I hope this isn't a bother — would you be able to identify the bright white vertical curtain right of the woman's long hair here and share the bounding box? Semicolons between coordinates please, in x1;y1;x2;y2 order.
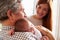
52;0;59;40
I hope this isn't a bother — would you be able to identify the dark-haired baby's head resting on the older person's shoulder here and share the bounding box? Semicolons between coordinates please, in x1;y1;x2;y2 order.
15;19;31;32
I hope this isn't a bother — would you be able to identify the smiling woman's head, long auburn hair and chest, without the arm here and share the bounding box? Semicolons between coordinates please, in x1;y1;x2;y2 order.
28;0;52;31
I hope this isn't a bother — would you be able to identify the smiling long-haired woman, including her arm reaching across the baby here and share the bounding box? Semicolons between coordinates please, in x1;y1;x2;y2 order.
28;0;55;40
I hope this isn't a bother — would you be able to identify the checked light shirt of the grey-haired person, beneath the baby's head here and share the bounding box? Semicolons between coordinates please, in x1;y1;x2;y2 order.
0;31;37;40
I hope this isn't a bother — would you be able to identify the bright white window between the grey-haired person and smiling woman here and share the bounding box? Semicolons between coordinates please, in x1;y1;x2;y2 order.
22;0;35;16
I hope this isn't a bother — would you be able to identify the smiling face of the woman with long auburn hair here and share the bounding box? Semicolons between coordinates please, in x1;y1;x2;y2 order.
36;4;48;19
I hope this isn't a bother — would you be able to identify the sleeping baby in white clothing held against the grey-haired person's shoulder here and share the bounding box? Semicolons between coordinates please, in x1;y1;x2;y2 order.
10;19;42;40
